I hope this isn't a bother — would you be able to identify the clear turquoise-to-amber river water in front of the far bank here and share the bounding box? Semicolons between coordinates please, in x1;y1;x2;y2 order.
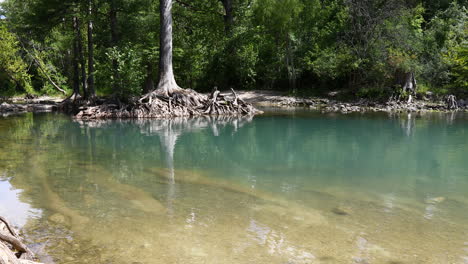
0;111;468;264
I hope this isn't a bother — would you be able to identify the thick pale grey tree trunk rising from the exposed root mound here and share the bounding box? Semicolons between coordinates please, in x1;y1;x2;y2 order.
157;0;180;96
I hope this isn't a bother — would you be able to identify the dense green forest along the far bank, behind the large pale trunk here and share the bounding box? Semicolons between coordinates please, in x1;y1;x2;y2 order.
0;0;468;98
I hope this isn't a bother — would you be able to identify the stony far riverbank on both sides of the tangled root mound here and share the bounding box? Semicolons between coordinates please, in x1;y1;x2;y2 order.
0;90;468;116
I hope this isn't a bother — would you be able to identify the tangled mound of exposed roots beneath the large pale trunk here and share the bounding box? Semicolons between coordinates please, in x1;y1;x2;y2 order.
66;88;261;119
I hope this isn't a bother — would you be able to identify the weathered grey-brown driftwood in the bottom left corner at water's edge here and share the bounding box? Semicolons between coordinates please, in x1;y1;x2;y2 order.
0;216;41;264
